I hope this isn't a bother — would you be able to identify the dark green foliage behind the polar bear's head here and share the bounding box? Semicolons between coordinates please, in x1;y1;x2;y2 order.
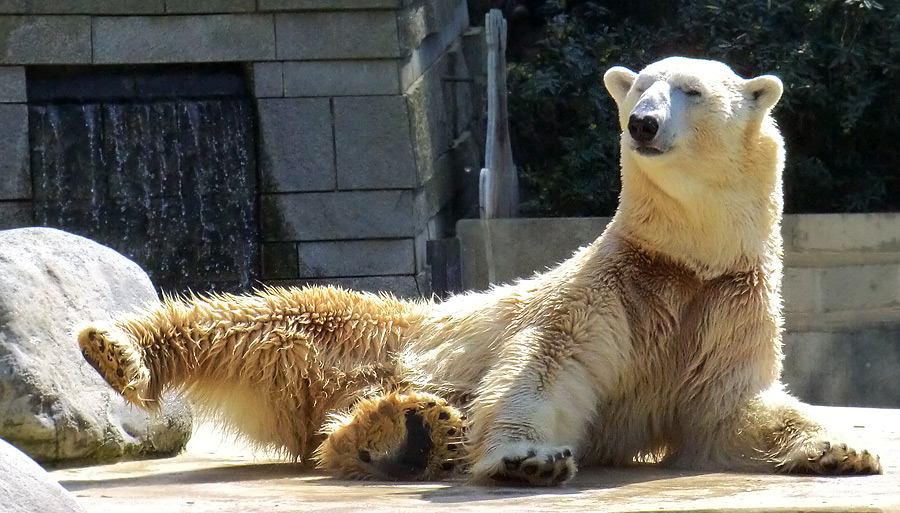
509;0;900;216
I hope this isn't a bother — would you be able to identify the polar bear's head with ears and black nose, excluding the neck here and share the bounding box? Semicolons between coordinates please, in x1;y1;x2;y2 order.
603;57;782;192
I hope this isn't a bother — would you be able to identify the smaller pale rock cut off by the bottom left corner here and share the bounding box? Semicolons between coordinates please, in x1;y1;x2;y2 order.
0;440;84;513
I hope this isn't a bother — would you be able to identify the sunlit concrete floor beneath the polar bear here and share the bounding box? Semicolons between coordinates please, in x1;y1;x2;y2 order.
51;408;900;513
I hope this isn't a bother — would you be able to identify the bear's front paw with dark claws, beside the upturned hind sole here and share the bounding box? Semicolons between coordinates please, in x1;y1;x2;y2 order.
472;443;577;486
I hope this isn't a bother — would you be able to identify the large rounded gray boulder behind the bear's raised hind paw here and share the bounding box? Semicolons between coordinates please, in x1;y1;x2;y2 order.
0;228;191;463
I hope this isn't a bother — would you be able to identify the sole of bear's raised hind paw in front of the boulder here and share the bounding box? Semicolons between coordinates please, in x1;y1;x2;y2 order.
78;327;151;408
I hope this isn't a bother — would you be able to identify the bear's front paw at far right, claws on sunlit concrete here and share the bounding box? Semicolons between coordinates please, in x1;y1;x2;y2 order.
778;438;882;476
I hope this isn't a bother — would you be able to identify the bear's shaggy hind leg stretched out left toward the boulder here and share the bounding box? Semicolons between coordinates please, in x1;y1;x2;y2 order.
78;287;414;462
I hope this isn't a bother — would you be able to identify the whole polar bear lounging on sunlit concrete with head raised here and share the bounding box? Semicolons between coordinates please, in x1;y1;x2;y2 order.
78;57;882;485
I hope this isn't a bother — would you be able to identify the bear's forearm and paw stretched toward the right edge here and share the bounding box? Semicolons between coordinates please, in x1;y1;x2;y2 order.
700;387;882;475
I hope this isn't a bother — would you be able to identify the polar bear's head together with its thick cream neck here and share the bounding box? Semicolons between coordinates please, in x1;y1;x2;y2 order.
604;57;784;276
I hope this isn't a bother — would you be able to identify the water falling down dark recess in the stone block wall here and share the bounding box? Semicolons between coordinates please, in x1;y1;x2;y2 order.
29;67;259;292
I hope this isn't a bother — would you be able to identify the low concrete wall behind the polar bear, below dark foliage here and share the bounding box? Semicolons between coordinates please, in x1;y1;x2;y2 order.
457;214;900;407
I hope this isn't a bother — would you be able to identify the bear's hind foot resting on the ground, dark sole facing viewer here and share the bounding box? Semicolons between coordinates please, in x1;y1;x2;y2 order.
314;392;464;479
